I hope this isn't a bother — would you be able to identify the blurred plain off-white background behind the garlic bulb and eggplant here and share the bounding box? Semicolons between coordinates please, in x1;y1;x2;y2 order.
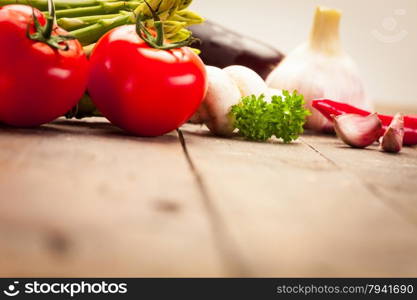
192;0;417;110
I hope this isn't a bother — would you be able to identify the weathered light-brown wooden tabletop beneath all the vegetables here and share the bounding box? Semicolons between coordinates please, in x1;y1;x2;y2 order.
0;119;417;277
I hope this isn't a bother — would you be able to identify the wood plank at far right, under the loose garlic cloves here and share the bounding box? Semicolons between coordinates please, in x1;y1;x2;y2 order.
303;135;417;226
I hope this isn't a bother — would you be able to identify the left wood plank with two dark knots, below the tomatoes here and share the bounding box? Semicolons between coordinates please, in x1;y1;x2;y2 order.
0;120;227;277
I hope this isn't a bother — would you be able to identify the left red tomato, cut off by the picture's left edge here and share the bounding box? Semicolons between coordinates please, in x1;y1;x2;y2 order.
0;5;88;127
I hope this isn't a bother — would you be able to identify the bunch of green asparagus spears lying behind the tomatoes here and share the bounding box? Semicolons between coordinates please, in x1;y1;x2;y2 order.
0;0;203;47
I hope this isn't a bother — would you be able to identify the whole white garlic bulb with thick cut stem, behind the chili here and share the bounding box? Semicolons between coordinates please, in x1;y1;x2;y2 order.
267;7;372;131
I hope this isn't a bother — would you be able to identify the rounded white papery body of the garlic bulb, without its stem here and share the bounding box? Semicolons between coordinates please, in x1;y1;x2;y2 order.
266;44;372;131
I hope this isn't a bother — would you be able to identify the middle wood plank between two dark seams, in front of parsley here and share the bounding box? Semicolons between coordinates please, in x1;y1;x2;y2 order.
183;125;417;276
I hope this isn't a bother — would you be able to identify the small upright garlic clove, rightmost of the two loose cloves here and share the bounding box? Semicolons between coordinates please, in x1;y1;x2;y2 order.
380;114;404;153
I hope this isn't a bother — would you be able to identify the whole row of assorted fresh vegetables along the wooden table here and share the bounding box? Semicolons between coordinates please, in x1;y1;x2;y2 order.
0;0;417;153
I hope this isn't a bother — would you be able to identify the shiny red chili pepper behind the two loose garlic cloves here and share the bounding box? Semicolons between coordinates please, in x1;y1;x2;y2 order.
312;99;417;146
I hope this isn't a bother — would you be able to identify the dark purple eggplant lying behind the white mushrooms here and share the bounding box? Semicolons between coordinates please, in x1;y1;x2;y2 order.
190;21;284;79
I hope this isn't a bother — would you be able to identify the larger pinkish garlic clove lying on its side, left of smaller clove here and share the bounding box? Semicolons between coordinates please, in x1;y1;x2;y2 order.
334;114;382;148
